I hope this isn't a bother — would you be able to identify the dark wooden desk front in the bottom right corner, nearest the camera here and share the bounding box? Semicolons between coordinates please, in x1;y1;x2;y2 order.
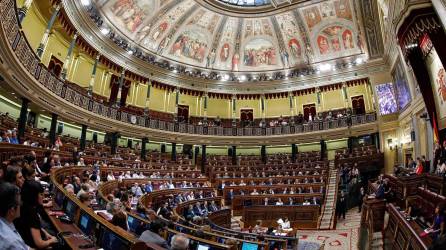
386;204;432;250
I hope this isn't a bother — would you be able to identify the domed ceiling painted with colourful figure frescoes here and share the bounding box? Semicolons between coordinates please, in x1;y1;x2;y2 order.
93;0;364;72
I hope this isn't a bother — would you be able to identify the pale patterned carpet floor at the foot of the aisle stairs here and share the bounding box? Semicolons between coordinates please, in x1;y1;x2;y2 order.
297;208;361;250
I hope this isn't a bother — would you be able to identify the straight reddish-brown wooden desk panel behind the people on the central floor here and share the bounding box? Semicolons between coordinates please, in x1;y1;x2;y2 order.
243;205;320;229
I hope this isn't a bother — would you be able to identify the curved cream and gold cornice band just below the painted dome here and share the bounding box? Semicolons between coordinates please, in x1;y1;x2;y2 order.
58;0;387;94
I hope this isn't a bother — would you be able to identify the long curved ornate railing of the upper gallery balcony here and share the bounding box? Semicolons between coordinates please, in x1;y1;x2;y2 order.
0;0;376;136
